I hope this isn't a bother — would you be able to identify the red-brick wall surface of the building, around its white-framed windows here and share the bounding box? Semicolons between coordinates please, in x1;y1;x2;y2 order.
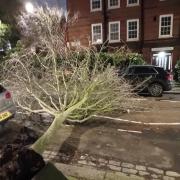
67;0;180;65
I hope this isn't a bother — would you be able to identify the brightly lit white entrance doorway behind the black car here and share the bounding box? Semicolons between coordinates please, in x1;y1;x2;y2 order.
152;52;172;71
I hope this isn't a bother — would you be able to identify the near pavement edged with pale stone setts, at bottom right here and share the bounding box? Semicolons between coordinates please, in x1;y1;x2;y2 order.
44;152;180;180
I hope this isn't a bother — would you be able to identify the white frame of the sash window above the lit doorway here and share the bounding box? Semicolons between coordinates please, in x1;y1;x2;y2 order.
159;14;174;38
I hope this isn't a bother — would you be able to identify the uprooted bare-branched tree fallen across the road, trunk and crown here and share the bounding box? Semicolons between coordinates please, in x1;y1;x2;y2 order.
5;8;139;153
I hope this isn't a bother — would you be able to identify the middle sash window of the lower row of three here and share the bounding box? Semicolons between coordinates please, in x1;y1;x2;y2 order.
109;21;120;42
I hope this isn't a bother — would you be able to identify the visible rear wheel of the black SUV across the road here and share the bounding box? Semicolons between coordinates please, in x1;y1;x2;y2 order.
148;83;163;97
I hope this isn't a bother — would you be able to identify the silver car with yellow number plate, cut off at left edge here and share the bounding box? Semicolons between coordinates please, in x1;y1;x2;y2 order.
0;85;16;126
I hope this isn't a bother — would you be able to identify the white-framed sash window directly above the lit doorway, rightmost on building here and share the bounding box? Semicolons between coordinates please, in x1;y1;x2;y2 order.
159;14;173;38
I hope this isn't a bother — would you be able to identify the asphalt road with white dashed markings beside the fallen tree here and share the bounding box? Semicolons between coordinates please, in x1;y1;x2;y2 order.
0;94;180;179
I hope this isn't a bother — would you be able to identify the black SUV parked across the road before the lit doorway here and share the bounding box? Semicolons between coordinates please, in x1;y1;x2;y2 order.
123;65;173;97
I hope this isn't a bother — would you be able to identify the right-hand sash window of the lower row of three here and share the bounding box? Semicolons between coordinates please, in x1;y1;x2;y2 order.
127;19;139;41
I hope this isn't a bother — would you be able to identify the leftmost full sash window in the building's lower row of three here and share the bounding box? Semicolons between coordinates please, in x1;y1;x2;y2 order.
91;23;103;44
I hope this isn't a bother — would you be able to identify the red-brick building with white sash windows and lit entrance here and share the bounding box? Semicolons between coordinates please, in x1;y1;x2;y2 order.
67;0;180;70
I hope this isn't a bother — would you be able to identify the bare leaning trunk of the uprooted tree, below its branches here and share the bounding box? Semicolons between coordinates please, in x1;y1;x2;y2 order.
31;113;67;154
